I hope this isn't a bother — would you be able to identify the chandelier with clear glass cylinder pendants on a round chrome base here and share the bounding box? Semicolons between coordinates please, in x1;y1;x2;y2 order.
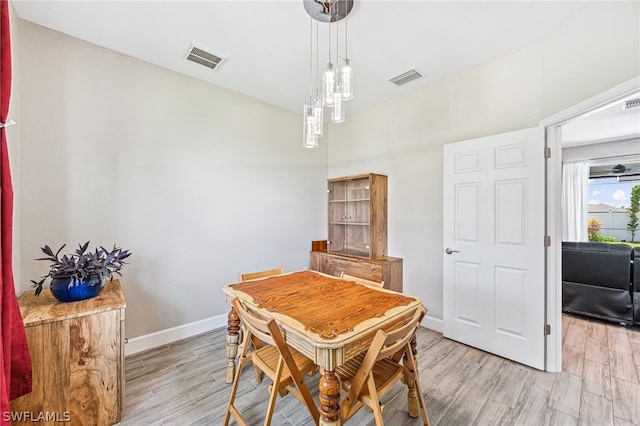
302;0;354;148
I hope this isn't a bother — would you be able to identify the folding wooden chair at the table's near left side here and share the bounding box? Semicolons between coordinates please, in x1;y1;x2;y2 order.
224;298;320;426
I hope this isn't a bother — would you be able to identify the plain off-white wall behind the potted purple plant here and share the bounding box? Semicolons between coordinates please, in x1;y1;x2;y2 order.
19;21;327;337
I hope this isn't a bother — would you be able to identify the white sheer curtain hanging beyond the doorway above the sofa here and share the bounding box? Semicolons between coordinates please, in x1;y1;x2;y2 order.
562;160;589;241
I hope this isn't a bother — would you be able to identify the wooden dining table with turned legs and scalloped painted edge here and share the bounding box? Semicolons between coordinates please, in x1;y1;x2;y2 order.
223;270;422;426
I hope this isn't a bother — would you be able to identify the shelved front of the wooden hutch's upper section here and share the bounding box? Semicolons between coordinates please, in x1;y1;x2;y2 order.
328;177;371;257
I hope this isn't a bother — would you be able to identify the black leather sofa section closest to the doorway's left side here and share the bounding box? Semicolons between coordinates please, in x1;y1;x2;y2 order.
562;242;640;324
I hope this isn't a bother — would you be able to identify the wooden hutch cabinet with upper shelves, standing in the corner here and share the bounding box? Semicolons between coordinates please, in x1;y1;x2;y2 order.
310;173;402;292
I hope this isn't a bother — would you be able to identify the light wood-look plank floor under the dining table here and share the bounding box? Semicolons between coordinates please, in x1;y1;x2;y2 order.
120;315;640;426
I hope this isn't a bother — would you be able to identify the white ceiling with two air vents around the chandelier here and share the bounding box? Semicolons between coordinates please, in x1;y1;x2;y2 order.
13;0;640;142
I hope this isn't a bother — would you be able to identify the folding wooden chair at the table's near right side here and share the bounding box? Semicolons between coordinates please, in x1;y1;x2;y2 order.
335;306;429;426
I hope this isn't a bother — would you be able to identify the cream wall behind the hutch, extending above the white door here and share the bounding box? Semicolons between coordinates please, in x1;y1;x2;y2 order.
329;2;640;325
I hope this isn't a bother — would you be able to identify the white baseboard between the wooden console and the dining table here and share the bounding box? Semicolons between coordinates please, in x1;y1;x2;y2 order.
124;314;227;356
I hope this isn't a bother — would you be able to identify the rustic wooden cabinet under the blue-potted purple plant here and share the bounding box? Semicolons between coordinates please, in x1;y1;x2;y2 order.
11;280;126;425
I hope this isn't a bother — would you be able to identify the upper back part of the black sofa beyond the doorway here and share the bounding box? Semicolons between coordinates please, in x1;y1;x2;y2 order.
562;242;632;291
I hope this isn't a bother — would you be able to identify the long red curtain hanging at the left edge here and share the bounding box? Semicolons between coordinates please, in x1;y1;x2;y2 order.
0;0;31;425
